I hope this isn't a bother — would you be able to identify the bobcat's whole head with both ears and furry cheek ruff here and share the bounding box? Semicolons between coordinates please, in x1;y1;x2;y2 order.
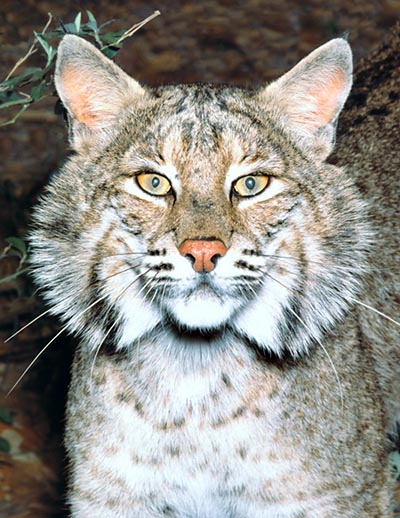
32;36;366;355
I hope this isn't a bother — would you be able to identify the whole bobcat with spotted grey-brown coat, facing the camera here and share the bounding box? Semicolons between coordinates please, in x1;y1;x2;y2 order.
31;35;399;518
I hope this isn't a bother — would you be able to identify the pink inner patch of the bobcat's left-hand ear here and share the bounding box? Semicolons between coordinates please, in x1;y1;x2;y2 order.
61;67;100;126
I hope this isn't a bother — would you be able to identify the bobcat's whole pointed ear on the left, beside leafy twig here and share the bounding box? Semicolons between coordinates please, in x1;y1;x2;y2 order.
55;35;146;147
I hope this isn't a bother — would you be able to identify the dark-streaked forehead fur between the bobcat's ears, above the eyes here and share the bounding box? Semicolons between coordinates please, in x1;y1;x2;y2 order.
134;85;272;173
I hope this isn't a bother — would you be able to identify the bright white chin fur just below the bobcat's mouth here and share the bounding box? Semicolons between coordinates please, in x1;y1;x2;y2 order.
167;294;237;329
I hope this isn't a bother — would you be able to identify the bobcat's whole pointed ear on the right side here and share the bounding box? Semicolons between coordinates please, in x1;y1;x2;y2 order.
260;38;352;159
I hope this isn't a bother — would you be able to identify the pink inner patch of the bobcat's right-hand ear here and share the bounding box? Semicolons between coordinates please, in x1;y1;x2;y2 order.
304;71;346;129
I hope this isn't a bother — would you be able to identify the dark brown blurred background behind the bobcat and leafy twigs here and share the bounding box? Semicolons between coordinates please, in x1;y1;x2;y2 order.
0;0;400;518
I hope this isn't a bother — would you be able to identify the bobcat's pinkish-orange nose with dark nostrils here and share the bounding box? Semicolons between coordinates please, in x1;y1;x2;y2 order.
179;239;227;273
